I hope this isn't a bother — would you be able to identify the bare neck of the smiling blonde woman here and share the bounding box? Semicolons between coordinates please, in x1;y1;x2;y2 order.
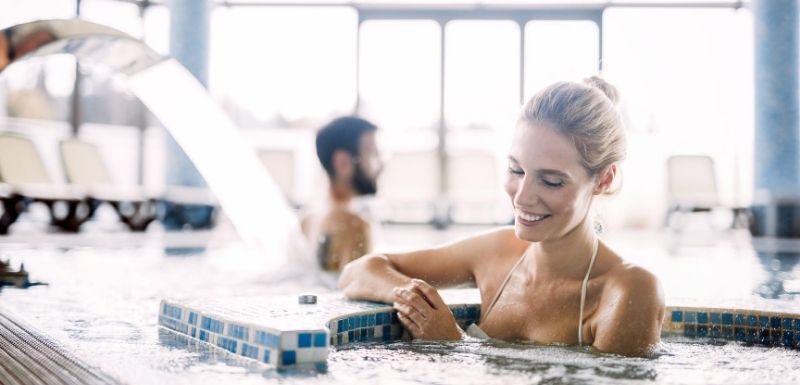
529;216;597;279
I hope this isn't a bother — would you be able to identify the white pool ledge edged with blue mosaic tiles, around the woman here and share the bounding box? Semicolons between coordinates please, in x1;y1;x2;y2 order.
159;289;800;367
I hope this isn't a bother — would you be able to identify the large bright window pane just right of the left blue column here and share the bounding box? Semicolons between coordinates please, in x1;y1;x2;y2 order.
209;6;357;128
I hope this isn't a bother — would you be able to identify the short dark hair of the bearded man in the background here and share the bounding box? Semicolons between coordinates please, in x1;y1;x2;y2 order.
317;116;378;178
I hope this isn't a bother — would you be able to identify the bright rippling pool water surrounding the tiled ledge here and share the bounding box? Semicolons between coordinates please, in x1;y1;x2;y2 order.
0;229;800;384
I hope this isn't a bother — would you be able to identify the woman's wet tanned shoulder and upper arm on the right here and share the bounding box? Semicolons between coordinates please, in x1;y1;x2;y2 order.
593;266;664;356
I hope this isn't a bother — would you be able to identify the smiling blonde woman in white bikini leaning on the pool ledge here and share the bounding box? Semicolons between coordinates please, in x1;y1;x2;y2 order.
339;77;664;355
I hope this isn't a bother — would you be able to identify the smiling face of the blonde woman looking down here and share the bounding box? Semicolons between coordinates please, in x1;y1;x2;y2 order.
506;122;595;242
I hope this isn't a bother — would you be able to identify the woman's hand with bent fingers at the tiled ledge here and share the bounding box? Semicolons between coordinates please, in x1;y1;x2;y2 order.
393;279;462;340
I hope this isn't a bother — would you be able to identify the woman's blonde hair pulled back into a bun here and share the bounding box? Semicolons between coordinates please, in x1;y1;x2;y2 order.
520;76;626;182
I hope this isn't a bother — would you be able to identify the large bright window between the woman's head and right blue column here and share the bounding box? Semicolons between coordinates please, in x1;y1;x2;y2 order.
603;8;754;223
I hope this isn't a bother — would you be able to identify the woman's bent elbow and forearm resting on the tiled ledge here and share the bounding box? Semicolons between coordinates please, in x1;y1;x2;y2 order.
339;255;411;303
